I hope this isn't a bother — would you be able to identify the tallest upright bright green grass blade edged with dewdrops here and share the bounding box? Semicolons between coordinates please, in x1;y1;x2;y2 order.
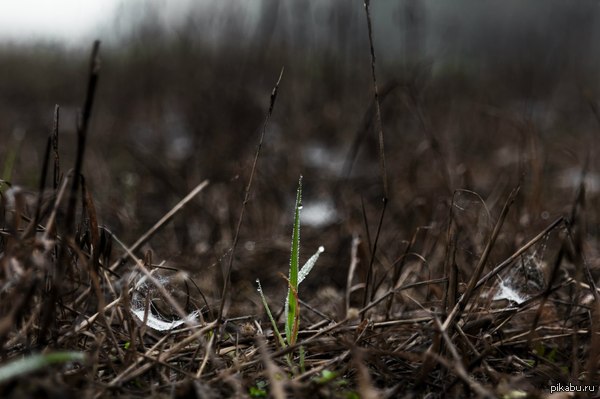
285;176;302;343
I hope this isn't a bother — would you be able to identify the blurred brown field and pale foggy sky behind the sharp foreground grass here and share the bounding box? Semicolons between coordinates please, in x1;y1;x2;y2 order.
0;0;600;312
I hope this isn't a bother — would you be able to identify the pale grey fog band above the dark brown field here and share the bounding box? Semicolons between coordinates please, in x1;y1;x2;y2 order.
0;0;600;66
